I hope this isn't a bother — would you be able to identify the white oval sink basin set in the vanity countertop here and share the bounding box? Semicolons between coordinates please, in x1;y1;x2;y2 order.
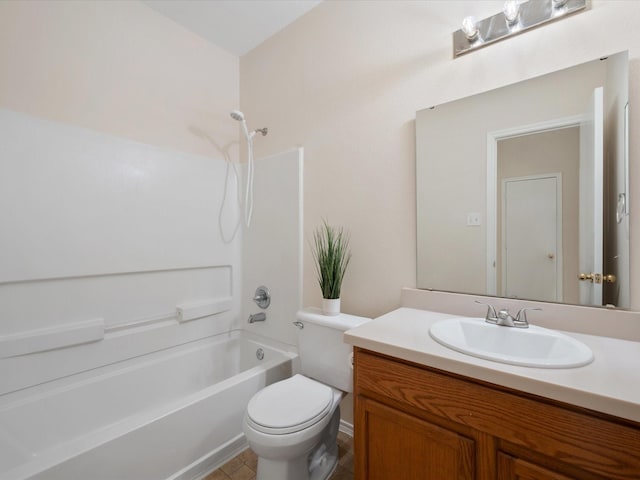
429;317;593;368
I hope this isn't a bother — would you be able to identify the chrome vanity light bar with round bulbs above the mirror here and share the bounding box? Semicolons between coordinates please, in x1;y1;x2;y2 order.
453;0;587;58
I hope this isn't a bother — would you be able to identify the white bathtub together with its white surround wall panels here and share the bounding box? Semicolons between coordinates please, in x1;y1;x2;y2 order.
0;109;302;480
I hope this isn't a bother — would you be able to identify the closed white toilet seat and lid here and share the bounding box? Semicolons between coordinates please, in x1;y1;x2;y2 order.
246;375;333;435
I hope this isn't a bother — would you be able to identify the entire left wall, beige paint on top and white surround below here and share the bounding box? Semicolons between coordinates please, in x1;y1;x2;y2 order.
0;1;242;396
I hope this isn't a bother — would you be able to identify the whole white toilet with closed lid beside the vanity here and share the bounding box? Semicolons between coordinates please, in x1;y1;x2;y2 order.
242;308;369;480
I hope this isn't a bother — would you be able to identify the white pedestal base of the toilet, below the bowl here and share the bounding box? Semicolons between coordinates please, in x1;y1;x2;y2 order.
256;407;340;480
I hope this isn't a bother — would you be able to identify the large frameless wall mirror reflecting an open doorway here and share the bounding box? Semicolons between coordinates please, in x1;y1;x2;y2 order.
416;52;629;308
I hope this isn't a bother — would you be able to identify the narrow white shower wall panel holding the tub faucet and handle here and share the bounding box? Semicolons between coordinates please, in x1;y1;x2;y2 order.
242;148;307;345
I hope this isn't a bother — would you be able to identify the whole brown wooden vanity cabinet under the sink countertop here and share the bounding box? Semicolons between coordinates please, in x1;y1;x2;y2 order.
354;347;640;480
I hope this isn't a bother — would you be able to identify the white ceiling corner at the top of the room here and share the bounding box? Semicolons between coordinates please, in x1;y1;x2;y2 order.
144;0;321;56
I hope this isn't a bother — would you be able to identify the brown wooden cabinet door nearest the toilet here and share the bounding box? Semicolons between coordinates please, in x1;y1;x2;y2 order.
355;396;475;480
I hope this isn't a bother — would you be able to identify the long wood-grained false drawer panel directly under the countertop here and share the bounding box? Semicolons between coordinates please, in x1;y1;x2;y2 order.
355;349;640;480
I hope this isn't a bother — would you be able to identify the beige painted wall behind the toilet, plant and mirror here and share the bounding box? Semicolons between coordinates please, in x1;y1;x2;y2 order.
240;0;640;316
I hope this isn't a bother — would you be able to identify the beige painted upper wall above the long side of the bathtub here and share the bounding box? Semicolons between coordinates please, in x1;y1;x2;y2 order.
0;0;239;158
